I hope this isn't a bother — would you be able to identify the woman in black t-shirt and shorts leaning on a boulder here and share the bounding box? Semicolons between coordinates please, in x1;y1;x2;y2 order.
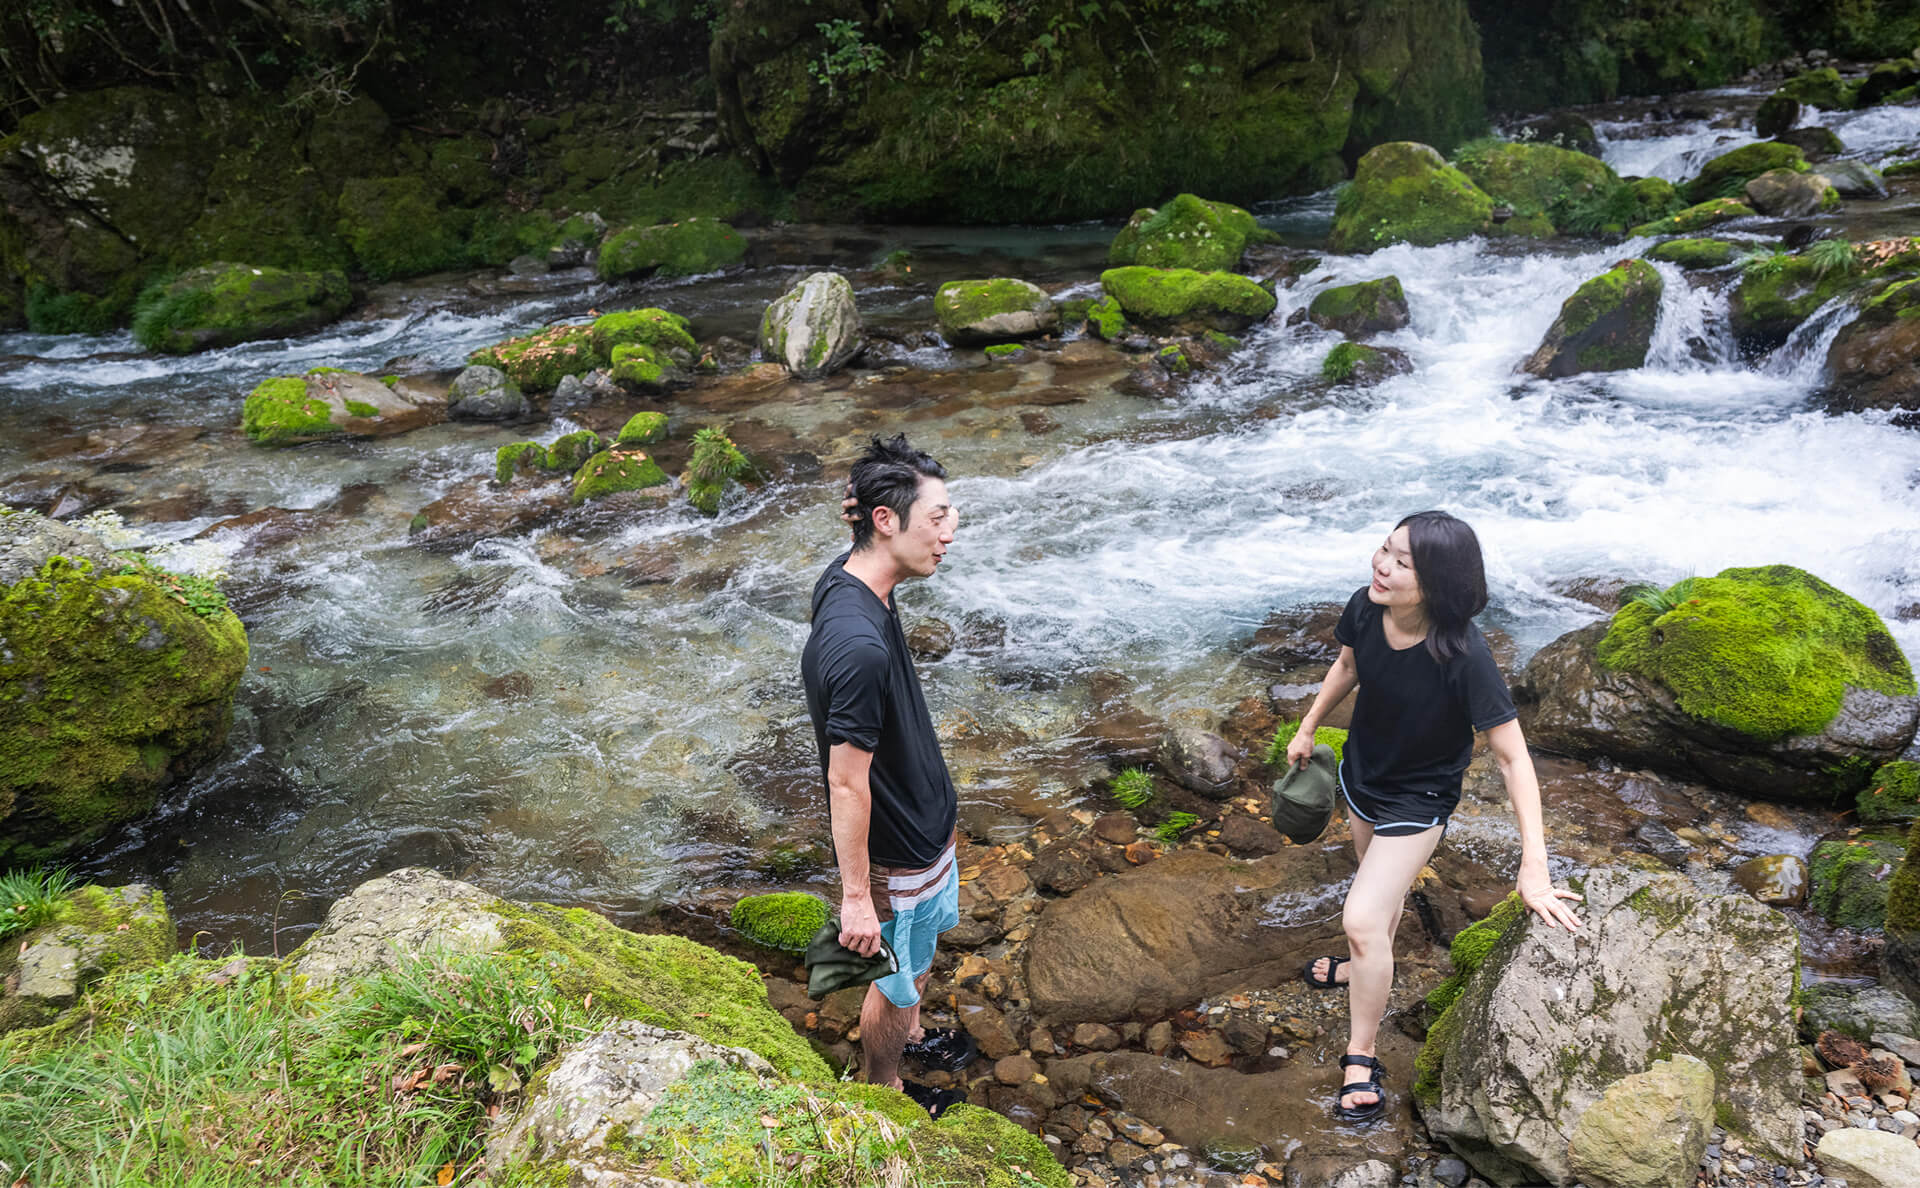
1286;511;1580;1123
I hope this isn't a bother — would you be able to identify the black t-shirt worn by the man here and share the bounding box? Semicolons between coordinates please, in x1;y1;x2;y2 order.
801;553;958;867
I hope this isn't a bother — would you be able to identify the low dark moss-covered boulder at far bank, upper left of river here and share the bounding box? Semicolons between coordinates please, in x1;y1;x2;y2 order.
132;263;353;355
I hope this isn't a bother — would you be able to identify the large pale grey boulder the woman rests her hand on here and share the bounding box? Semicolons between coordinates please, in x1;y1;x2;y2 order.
1423;869;1801;1186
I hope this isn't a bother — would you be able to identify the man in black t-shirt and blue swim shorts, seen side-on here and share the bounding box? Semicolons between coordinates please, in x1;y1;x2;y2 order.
801;436;973;1117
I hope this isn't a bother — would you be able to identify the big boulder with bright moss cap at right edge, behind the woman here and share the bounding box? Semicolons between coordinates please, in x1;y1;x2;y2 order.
1515;566;1920;802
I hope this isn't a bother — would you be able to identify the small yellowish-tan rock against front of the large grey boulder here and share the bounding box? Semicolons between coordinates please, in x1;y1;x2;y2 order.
1567;1054;1713;1188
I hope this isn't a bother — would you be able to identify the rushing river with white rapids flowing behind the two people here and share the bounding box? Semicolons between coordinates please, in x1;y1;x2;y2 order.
0;94;1920;952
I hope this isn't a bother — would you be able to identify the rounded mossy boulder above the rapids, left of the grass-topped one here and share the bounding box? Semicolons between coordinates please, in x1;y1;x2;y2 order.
1329;140;1494;251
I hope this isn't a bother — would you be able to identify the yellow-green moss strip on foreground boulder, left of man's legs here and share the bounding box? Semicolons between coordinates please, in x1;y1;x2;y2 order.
495;902;829;1081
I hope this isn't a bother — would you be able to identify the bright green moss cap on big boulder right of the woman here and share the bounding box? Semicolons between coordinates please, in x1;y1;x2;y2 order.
1596;564;1914;741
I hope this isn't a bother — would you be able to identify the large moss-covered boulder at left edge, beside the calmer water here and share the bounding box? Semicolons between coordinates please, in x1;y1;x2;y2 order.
0;512;248;862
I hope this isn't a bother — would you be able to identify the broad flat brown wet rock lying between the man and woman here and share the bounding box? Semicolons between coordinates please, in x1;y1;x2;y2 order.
1027;850;1348;1021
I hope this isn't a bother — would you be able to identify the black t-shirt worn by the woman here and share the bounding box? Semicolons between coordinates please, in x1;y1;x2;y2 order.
1332;587;1519;796
